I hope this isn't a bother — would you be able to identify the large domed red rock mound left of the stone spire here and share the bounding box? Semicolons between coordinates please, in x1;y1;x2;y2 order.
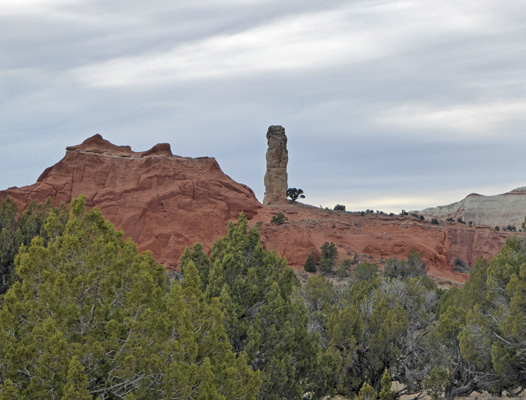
0;135;261;267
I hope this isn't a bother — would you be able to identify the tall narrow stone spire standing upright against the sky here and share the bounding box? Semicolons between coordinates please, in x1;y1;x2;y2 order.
263;125;289;205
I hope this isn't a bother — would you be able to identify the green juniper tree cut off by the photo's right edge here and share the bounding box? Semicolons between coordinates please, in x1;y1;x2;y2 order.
455;238;526;394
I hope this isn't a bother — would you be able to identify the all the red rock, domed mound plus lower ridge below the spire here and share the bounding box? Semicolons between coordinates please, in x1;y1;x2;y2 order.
0;135;520;283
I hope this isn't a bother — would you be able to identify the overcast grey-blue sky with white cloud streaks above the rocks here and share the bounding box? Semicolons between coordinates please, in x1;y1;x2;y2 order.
0;0;526;212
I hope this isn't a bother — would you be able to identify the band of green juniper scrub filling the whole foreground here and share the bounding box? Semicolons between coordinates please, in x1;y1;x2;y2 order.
0;199;526;400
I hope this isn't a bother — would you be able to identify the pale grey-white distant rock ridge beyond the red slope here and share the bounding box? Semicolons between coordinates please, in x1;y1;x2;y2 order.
418;187;526;230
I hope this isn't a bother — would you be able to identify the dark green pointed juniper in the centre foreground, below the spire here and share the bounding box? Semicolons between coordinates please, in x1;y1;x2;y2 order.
181;214;325;399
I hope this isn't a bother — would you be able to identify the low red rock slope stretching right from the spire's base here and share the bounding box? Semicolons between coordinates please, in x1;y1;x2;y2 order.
251;204;524;284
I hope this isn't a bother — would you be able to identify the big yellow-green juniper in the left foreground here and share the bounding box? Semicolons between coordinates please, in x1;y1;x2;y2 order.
0;198;259;399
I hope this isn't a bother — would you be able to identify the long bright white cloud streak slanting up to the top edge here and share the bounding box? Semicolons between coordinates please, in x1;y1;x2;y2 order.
69;1;520;87
